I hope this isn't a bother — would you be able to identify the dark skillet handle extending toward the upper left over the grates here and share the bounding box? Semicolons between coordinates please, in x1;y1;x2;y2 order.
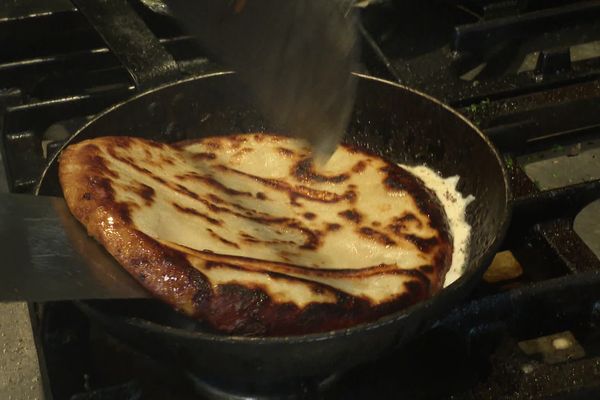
71;0;183;90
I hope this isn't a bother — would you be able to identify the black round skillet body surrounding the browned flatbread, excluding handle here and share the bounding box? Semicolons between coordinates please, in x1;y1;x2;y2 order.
36;73;510;387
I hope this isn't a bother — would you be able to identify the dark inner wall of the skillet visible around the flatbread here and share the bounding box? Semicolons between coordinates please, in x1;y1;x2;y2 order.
38;73;508;338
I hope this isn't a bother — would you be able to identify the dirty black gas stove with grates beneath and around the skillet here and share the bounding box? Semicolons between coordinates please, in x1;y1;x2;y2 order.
0;0;600;400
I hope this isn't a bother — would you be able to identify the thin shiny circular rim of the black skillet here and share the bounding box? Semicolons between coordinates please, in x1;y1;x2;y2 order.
34;71;513;345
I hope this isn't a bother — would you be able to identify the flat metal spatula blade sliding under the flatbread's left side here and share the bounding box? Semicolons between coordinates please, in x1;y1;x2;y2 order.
0;193;149;302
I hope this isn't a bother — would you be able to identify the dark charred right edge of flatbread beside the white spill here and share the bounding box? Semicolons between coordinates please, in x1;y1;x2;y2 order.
380;164;450;242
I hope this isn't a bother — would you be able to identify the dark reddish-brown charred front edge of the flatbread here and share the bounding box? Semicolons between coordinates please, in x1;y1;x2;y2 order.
186;256;429;336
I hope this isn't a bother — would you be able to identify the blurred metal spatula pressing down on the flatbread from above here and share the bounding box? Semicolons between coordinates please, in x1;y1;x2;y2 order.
165;0;358;161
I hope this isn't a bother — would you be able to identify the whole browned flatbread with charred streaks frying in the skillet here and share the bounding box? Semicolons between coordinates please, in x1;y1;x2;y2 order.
59;134;452;335
